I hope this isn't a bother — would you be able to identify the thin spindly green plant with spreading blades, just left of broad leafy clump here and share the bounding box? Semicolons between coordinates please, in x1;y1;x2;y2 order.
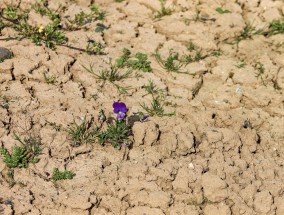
83;62;133;93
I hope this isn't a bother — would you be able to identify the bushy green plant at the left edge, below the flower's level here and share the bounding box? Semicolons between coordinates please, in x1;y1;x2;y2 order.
0;134;42;168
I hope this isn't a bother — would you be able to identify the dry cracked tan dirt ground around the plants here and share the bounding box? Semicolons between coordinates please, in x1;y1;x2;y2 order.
0;0;284;215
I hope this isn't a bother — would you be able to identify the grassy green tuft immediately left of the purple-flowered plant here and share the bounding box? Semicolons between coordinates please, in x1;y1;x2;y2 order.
67;116;97;146
